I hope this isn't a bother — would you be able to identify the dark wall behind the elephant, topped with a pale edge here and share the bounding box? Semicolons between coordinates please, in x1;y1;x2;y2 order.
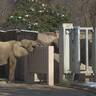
0;29;38;79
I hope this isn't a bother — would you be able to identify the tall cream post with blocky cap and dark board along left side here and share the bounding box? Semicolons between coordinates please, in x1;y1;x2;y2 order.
59;23;73;82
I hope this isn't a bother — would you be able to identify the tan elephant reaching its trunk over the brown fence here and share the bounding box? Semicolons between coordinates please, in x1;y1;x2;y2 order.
0;39;39;82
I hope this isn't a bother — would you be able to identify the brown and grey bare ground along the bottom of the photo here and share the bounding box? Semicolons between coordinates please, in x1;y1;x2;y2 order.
0;84;96;96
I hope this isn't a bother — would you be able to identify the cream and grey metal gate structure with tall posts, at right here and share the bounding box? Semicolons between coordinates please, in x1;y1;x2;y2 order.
59;23;95;82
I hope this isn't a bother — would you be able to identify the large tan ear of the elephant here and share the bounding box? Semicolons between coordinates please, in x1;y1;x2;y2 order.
13;42;28;57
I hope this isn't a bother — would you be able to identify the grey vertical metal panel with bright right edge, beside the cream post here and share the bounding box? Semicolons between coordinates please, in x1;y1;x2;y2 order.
71;27;80;73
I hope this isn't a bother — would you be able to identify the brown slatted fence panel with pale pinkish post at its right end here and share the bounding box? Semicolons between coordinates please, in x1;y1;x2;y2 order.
18;46;54;86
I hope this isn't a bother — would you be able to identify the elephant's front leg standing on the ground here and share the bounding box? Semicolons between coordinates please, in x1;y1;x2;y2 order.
9;57;16;82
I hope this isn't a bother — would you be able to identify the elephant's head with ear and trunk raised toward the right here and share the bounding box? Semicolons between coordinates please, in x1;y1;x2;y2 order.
13;39;38;57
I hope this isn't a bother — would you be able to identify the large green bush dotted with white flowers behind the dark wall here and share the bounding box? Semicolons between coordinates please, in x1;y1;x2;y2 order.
6;0;71;32
